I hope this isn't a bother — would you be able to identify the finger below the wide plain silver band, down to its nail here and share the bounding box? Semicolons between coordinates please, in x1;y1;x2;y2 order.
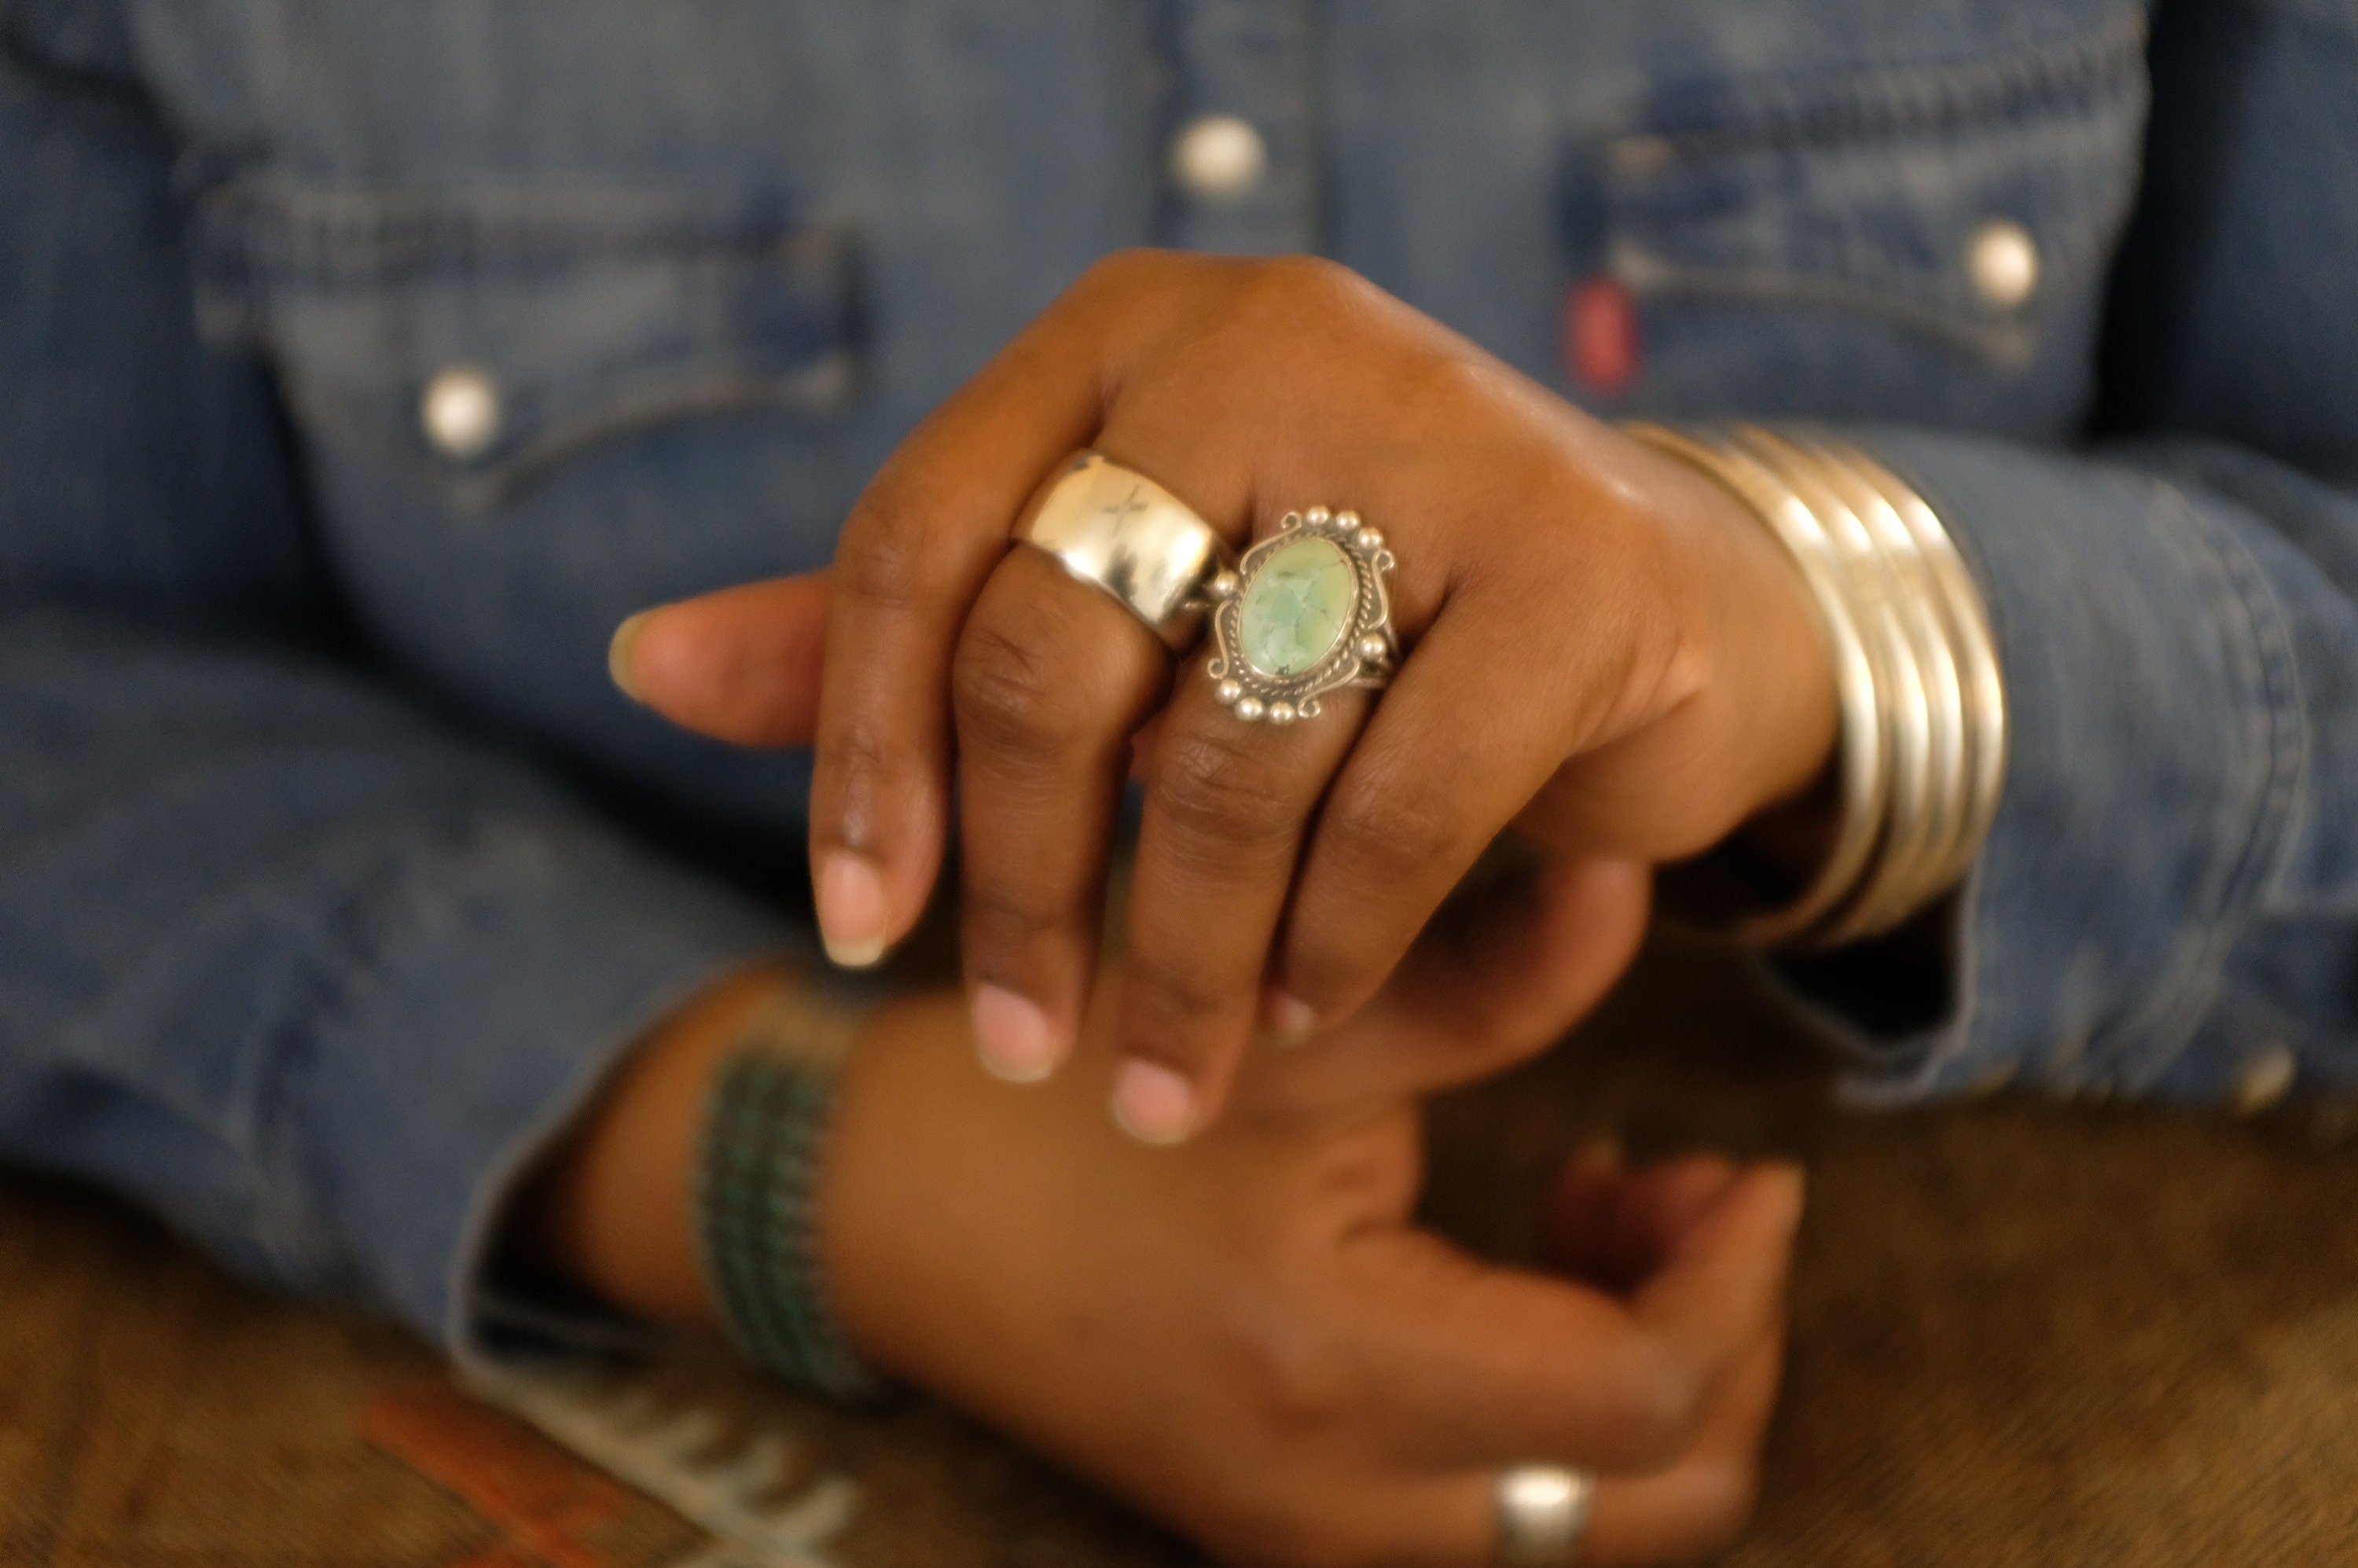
953;549;1170;1082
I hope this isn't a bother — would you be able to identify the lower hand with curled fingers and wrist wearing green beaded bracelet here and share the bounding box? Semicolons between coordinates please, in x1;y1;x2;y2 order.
526;967;1802;1566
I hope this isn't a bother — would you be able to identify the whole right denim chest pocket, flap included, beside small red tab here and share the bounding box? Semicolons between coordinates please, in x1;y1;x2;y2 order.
1575;14;2146;427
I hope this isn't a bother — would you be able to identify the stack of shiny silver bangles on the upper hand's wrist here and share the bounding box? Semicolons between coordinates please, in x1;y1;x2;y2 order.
1625;424;2007;948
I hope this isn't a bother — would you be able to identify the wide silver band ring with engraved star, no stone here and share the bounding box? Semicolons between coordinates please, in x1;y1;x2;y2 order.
1014;453;1229;653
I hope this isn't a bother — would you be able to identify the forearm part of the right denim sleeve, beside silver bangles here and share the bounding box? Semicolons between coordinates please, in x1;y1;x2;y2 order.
1783;431;2358;1101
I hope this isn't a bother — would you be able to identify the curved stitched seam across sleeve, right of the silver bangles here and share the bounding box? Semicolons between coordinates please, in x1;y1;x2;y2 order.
2101;481;2308;1087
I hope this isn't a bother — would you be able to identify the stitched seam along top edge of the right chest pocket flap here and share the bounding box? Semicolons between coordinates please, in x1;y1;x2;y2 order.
1651;12;2146;158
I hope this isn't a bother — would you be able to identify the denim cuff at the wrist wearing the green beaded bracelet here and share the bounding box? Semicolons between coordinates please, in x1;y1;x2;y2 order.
281;821;809;1363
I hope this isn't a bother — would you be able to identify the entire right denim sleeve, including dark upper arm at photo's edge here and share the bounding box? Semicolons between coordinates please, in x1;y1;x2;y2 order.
1787;0;2358;1103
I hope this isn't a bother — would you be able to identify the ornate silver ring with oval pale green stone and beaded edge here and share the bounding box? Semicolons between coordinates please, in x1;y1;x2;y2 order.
1205;507;1401;724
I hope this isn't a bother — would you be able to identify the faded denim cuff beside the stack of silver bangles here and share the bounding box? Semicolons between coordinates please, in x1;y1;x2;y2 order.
1771;431;2306;1103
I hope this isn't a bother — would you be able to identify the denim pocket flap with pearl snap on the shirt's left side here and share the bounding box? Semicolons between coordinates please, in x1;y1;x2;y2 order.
193;177;858;512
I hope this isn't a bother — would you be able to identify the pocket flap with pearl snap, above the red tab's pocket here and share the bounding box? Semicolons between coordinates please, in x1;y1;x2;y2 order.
1596;14;2143;363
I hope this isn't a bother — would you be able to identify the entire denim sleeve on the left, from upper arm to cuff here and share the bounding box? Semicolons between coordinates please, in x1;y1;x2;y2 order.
0;18;797;1351
